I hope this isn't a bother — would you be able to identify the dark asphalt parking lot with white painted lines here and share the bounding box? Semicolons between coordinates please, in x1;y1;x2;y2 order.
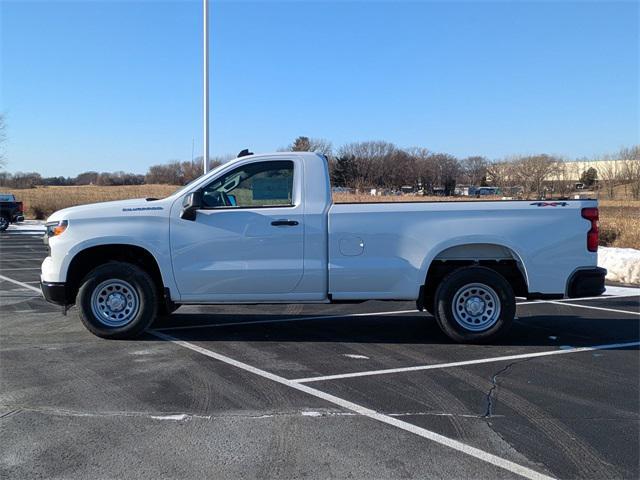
0;231;640;479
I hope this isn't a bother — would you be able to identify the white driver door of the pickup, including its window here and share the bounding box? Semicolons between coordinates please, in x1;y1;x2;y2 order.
170;159;304;302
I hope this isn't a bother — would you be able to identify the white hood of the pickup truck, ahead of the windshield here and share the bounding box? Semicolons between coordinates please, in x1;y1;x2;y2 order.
47;198;171;222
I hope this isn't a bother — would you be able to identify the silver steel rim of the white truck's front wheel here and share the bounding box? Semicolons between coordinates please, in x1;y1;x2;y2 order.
91;279;140;328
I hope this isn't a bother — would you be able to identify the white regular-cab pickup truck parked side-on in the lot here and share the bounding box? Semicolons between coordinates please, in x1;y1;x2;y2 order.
41;152;606;342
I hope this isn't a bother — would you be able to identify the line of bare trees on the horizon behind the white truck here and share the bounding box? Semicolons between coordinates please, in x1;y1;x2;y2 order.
0;136;640;199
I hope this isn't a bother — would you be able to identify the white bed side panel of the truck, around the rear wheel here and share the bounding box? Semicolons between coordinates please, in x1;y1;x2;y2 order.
329;200;597;299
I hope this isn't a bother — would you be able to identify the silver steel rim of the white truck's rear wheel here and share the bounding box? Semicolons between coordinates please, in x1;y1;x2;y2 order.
451;283;500;332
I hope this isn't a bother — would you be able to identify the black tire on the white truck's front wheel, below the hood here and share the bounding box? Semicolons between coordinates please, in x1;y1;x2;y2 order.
76;262;158;339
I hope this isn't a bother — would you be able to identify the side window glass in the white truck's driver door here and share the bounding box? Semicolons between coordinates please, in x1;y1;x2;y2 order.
202;160;293;208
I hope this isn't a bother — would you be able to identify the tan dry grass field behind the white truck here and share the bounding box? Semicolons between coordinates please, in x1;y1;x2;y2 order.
0;185;640;249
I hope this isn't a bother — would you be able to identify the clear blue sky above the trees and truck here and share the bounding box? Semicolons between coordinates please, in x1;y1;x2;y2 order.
0;0;640;175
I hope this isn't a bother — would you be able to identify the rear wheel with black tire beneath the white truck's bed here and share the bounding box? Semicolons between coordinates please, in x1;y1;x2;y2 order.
434;267;516;343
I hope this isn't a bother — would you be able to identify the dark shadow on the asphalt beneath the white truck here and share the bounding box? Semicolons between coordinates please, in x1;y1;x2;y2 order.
145;311;640;349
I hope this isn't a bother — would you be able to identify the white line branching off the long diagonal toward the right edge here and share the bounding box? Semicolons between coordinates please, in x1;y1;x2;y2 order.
291;342;640;383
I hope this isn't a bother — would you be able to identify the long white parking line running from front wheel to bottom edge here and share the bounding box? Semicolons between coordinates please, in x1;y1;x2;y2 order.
150;331;552;480
